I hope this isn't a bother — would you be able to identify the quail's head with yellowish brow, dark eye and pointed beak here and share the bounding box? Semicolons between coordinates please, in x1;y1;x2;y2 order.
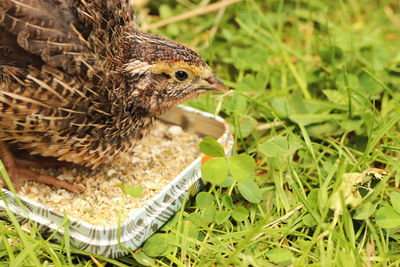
123;30;226;116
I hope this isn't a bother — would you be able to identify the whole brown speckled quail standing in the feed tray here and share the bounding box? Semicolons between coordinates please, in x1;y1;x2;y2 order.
0;0;227;192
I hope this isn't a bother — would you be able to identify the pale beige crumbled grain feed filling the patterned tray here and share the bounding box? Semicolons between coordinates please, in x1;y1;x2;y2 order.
19;121;200;226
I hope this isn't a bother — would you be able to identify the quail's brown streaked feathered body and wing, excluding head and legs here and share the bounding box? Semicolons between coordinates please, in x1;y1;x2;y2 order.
0;0;139;166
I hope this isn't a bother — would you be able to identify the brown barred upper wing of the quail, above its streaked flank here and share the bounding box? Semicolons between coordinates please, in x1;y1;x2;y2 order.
0;0;136;80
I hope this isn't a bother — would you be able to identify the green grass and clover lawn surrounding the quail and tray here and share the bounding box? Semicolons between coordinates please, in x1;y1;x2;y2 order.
0;0;400;266
